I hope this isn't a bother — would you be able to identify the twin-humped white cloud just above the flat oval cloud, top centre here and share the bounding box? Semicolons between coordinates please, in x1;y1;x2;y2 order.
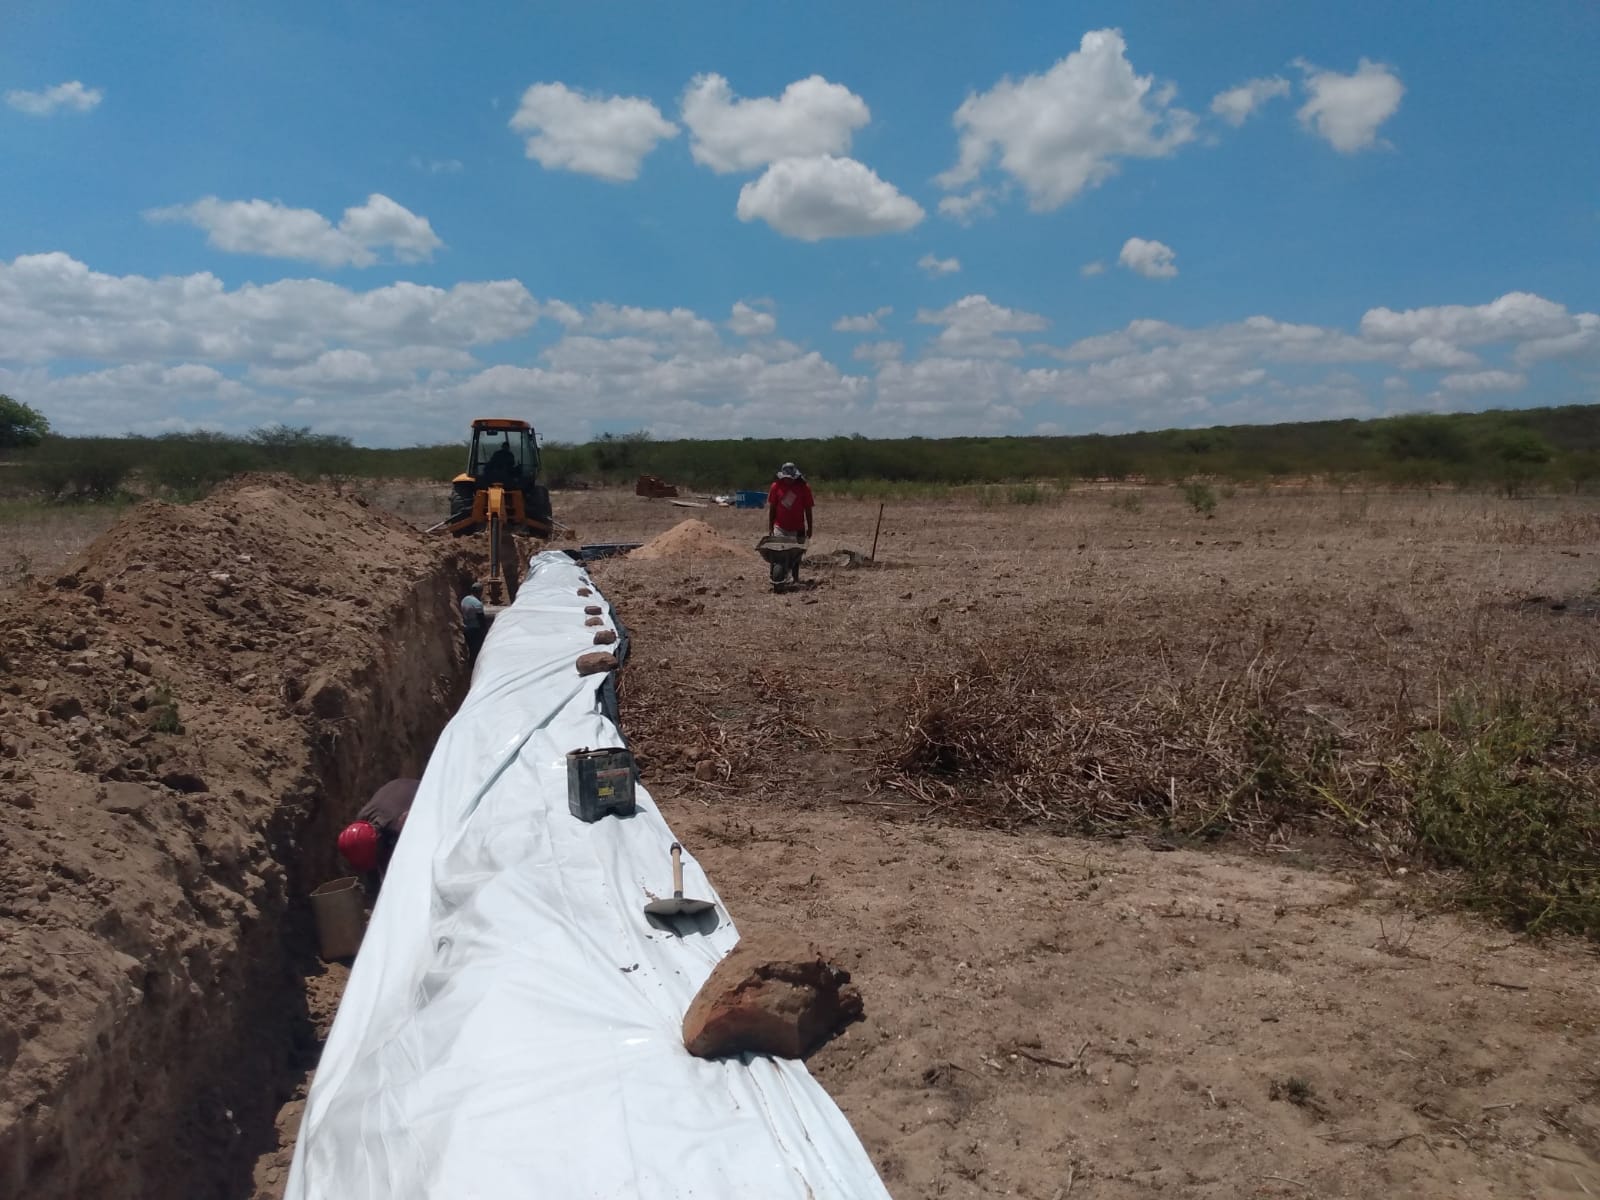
680;75;872;174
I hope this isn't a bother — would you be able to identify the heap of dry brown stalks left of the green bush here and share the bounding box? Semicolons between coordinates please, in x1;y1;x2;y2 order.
880;643;1336;838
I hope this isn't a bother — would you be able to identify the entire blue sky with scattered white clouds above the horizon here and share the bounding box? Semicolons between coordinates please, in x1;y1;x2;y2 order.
0;0;1600;445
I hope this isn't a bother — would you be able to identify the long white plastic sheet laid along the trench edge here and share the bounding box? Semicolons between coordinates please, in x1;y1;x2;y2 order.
286;552;888;1200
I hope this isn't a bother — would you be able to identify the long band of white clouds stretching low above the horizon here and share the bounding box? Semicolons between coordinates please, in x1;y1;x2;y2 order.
0;253;1600;445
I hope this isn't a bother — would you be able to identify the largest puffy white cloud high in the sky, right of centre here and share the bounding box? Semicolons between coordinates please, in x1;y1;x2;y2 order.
939;29;1195;211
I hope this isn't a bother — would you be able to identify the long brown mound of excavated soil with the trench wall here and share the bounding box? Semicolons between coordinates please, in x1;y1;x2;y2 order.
0;477;461;1200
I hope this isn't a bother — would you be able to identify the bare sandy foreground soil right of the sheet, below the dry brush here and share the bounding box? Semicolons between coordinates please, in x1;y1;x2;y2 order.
667;800;1600;1200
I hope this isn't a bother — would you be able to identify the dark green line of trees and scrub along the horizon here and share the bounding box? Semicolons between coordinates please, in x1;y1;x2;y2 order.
0;397;1600;501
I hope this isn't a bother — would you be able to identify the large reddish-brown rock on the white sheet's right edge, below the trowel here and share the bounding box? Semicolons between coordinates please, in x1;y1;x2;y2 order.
683;933;862;1058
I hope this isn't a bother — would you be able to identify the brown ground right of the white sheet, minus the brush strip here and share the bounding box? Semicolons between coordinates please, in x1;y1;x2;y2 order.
562;490;1600;1200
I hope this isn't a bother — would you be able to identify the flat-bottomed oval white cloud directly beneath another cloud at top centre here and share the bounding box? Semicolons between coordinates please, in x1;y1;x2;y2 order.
738;155;923;242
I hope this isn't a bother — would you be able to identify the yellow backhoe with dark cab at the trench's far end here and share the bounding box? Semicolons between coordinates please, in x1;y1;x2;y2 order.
445;418;555;603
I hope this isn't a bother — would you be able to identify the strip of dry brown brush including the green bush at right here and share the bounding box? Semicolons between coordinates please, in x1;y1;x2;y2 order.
875;635;1600;934
